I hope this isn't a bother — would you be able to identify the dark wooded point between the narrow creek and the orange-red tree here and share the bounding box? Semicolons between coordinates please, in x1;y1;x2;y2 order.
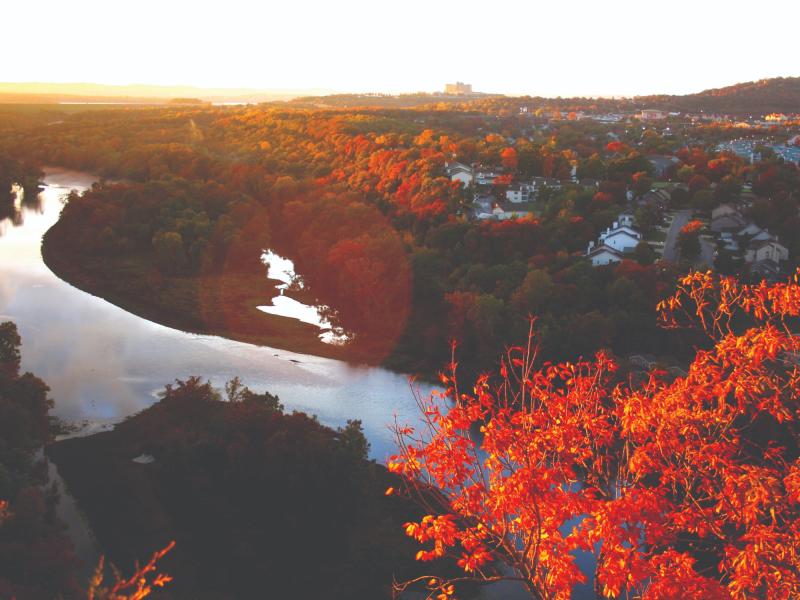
48;378;454;599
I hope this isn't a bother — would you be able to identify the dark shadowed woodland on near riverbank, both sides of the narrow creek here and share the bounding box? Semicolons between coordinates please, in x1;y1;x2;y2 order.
0;322;454;600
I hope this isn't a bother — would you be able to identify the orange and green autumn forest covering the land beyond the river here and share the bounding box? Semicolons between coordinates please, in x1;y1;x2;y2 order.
4;87;800;380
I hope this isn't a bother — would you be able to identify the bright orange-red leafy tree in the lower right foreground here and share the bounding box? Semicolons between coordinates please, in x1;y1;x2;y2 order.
389;273;800;599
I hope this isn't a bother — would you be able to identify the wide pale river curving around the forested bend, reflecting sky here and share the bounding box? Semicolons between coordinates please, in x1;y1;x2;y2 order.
0;169;432;460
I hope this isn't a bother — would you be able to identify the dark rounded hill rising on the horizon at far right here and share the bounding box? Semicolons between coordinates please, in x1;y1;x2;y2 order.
635;77;800;115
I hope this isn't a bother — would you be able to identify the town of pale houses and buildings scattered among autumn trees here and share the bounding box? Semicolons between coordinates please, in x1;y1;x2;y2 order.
444;82;800;280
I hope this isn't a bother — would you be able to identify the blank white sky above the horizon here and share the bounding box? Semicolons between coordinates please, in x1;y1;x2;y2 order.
0;0;800;96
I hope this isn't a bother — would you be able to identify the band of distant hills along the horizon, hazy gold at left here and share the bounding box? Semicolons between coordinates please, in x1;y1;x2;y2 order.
0;77;800;115
